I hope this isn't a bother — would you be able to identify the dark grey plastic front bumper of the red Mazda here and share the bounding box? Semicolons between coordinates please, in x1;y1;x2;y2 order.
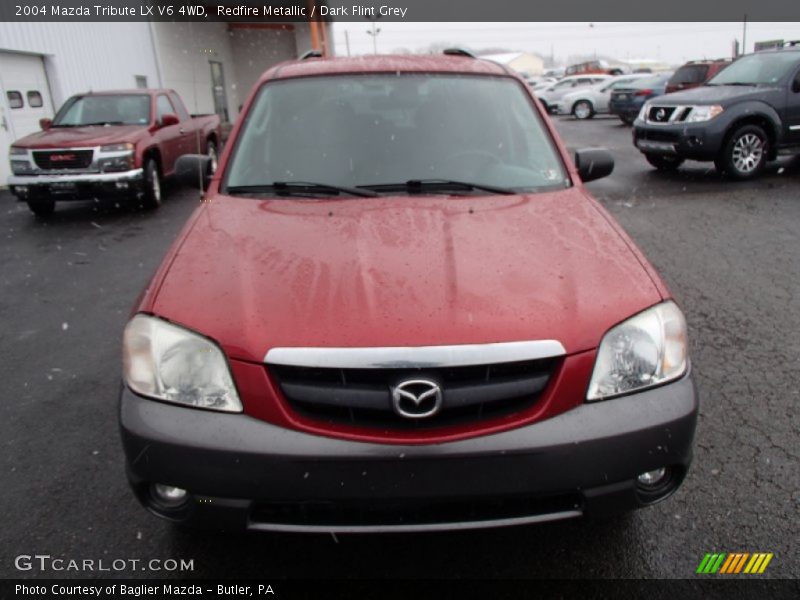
115;375;698;532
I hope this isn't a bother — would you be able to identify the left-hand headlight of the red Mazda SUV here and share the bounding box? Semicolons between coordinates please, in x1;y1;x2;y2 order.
122;314;242;412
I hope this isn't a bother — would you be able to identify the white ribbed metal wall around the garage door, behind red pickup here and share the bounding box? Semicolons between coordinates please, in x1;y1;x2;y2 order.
0;22;159;109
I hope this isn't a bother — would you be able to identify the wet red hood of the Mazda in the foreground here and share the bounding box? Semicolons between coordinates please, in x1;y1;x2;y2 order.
150;188;661;362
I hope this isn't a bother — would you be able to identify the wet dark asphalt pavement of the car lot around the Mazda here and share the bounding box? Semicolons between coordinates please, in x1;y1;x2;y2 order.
0;118;800;578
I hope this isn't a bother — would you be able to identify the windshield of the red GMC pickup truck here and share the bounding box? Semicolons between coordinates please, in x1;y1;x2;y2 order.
53;94;150;127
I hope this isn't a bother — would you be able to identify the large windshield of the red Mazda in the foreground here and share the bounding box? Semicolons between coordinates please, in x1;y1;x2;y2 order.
225;74;569;190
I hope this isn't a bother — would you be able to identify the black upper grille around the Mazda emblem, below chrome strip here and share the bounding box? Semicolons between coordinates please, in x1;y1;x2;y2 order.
268;358;558;430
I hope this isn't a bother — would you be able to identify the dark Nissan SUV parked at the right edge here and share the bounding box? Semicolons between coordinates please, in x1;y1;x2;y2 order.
633;44;800;179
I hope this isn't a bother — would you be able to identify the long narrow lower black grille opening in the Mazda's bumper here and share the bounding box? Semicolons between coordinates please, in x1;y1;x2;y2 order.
250;493;583;527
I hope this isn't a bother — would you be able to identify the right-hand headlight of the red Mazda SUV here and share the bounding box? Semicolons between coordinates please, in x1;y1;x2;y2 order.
586;302;688;400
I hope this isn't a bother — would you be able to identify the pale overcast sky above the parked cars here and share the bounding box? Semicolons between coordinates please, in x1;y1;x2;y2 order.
333;20;800;64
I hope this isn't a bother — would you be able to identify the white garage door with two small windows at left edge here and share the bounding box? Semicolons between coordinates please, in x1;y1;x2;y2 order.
0;52;53;185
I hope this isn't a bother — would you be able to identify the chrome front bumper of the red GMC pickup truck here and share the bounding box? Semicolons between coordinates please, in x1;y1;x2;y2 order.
8;169;144;200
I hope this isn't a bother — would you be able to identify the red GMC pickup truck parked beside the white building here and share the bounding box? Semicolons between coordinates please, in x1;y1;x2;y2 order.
8;89;220;216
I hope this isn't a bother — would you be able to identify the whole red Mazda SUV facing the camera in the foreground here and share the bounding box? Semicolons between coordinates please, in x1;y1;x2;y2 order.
120;53;698;532
